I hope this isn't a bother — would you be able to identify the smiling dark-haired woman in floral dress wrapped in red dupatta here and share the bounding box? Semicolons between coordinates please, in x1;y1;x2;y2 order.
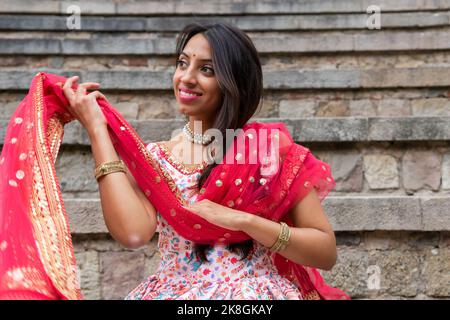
0;23;348;299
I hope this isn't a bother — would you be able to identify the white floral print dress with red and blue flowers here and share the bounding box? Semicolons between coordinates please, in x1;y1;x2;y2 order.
125;143;302;300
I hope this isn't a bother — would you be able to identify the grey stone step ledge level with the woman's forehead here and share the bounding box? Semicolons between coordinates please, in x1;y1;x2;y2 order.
0;29;450;56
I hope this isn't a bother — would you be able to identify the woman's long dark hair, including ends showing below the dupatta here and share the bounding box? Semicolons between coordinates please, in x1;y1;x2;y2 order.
176;23;263;261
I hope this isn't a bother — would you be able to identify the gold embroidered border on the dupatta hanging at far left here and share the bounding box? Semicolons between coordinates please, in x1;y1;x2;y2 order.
30;74;82;299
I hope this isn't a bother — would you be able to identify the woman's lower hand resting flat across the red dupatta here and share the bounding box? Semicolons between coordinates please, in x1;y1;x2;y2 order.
185;199;249;231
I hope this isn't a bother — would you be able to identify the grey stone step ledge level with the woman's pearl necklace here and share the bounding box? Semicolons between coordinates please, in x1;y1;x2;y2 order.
0;117;450;146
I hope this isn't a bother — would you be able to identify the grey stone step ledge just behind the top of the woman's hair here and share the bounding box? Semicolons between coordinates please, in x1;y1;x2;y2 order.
0;11;450;33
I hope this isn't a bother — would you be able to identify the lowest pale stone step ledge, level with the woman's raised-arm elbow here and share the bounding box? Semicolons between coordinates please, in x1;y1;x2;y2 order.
63;194;450;234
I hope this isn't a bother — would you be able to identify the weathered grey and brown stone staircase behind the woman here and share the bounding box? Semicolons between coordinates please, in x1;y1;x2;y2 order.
0;0;450;299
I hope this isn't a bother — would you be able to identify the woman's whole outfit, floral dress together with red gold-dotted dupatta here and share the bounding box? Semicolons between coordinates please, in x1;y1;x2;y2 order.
0;73;349;299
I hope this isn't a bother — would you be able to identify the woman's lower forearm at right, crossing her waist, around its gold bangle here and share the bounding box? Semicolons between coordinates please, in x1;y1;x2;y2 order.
241;212;336;270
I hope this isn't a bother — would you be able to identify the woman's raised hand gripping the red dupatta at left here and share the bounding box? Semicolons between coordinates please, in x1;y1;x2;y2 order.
63;76;107;134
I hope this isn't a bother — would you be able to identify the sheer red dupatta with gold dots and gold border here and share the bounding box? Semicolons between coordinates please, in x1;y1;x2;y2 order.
0;73;349;299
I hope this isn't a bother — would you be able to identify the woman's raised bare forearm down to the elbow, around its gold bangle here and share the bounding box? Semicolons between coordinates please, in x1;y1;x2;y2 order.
88;126;156;247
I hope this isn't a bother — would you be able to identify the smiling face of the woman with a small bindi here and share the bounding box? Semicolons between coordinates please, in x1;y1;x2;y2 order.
173;33;222;122
